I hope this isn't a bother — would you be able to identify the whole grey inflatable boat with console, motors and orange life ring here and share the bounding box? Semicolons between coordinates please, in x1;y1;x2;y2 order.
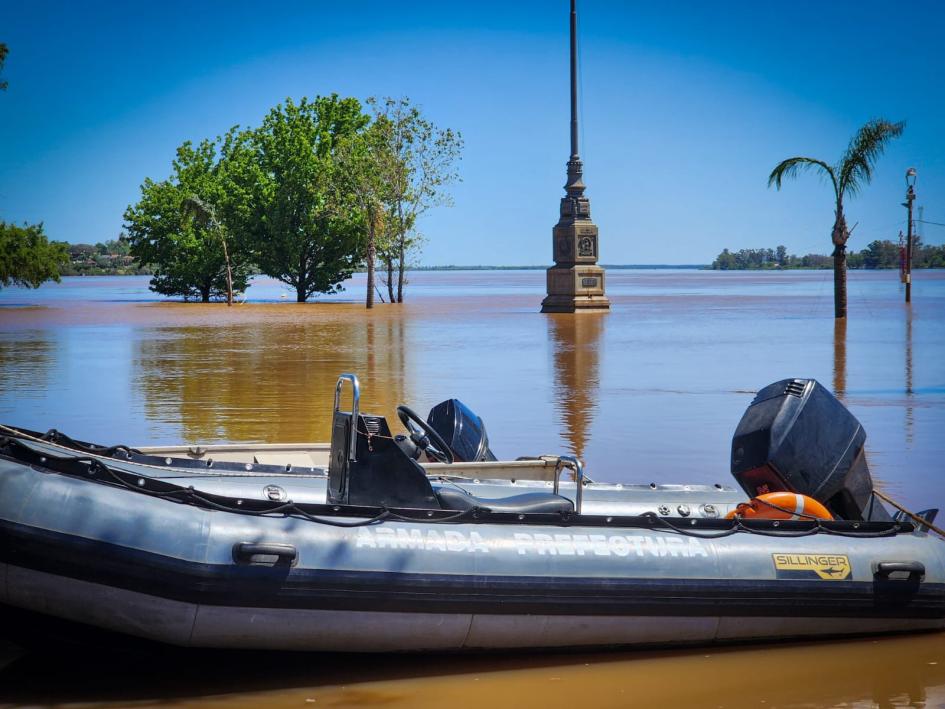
0;375;945;652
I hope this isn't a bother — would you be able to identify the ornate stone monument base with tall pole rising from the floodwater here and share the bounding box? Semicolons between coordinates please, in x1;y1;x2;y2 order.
541;0;610;313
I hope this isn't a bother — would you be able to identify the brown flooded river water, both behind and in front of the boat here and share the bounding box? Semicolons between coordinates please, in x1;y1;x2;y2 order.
0;270;945;707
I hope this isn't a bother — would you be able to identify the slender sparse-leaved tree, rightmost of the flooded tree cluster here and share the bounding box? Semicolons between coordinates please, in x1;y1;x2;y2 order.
367;98;463;303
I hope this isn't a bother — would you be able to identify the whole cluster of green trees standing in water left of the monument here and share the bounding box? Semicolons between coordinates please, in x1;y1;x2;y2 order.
125;95;462;307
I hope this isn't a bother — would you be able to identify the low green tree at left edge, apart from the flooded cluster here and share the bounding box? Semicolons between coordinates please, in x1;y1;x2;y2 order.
0;221;69;288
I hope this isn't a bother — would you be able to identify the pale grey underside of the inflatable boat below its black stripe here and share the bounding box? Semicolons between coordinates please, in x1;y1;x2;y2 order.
3;565;942;652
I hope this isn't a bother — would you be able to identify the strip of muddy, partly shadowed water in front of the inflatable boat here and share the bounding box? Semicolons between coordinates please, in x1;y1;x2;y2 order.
0;633;945;709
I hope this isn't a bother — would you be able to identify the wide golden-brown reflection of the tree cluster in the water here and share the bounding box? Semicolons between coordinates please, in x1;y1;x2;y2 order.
133;317;409;442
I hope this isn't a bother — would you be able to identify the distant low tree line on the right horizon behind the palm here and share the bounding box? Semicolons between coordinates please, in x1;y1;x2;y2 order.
712;236;945;271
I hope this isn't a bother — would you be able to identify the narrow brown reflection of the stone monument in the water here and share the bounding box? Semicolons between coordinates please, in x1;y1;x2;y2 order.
547;313;607;458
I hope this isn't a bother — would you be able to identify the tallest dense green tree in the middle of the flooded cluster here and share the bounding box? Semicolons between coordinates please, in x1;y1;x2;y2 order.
227;94;370;303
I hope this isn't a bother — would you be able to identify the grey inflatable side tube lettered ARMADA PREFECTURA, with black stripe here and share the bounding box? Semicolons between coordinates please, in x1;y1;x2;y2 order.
0;459;945;652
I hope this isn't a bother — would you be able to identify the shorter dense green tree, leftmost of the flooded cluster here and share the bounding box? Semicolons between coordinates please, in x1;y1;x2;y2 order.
125;140;250;303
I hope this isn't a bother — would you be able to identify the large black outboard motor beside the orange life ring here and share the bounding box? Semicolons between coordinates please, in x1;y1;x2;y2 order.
732;379;890;521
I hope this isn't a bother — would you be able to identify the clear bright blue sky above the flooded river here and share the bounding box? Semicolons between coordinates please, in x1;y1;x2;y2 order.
0;0;945;265
